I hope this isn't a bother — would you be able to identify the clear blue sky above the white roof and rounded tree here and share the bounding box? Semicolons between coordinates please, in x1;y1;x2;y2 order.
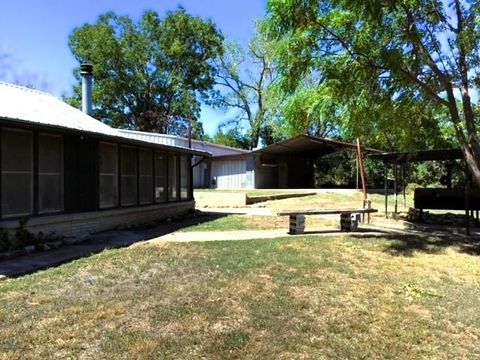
0;0;265;135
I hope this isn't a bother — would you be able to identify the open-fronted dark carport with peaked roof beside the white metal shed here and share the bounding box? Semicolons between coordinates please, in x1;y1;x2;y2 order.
253;135;379;189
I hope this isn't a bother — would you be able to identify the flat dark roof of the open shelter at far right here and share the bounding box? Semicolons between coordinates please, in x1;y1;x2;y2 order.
369;149;464;164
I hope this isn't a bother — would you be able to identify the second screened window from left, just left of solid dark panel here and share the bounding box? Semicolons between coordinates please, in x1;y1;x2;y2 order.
38;134;63;214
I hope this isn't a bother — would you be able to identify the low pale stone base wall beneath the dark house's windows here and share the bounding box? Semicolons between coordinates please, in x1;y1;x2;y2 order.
0;201;195;239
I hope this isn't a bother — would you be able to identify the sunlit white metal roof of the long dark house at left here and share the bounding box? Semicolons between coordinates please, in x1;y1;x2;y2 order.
0;82;211;156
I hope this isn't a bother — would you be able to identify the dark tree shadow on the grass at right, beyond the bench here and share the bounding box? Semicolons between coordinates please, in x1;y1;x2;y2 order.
352;232;480;257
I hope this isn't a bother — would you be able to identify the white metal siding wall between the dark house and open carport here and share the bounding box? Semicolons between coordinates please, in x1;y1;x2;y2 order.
212;159;248;189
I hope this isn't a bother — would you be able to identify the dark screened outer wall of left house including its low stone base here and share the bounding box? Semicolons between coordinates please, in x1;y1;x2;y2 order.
0;122;195;245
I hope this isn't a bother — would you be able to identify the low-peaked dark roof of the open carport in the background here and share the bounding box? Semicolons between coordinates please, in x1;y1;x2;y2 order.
253;135;381;157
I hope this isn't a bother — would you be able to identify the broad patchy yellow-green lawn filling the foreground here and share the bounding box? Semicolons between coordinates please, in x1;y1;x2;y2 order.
0;232;480;359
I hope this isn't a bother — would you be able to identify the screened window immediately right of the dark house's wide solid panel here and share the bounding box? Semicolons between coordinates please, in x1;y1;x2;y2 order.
99;142;118;209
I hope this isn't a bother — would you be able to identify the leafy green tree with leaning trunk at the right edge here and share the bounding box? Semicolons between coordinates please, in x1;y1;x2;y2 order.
266;0;480;184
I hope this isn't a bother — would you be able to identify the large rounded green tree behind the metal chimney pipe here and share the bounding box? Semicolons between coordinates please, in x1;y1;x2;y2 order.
69;8;223;135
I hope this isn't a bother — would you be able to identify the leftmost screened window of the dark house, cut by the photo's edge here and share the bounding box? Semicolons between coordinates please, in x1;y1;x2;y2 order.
2;128;33;217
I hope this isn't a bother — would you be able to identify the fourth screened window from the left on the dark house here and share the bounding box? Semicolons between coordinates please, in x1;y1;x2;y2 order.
120;146;137;206
